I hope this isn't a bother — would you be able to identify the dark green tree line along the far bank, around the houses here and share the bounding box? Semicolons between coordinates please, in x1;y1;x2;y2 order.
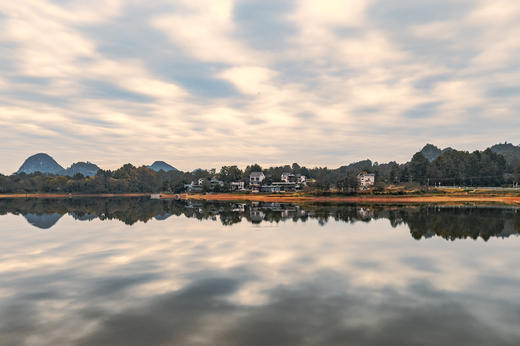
0;149;520;193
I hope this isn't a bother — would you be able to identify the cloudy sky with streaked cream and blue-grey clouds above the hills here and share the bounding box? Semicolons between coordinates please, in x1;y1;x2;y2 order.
0;0;520;174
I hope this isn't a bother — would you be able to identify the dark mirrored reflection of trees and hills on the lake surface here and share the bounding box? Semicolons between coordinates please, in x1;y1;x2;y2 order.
0;198;520;240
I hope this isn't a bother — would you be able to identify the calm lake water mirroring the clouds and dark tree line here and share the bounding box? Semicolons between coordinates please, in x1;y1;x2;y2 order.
0;199;520;346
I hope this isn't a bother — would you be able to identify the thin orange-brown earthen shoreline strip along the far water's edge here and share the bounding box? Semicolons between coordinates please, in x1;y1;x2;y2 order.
0;192;520;205
